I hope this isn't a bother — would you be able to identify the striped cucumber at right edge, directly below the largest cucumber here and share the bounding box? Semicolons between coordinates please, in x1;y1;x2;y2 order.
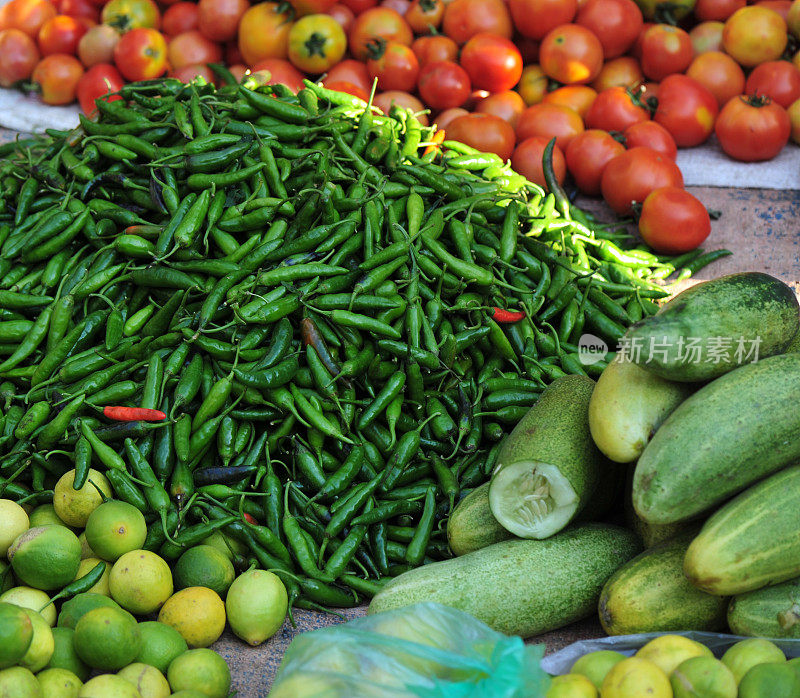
683;462;800;595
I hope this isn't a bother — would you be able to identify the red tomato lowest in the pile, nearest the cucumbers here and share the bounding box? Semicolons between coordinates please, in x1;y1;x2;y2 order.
639;187;711;254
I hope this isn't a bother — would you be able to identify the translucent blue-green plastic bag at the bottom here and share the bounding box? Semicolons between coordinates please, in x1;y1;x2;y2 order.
269;603;550;698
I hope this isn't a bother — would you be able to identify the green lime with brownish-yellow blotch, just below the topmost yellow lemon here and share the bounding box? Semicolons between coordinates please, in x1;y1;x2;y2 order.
85;500;147;562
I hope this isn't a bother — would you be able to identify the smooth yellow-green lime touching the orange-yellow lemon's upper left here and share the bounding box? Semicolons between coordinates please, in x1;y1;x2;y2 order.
108;550;172;614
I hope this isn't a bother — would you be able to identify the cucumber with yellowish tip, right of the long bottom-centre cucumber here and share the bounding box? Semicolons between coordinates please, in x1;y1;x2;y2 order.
598;530;728;635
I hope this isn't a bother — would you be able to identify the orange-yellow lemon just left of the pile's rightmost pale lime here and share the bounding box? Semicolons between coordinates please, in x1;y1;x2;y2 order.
158;587;225;644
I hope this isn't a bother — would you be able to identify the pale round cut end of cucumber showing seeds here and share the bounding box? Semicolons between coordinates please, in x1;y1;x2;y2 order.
489;461;579;539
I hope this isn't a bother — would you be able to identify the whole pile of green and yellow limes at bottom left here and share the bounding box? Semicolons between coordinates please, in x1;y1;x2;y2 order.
0;484;287;698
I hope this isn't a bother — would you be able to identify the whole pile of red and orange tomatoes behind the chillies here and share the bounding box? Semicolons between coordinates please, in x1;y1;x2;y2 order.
0;0;800;250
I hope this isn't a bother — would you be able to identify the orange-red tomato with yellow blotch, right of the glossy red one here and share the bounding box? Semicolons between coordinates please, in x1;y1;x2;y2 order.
539;24;603;85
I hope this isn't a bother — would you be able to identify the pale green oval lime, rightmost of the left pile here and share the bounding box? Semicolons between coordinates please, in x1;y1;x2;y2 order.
225;570;289;645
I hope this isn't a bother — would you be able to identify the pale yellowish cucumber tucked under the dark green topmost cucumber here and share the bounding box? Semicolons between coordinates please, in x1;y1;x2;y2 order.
589;353;694;463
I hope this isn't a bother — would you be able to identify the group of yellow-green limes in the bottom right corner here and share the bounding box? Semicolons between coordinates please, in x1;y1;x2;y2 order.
546;635;800;698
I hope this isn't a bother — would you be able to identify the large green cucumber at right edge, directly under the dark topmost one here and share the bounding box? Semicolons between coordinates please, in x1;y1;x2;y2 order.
633;354;800;523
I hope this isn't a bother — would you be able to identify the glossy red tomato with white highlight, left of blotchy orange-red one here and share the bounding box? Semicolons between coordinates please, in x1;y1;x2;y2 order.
461;34;522;92
